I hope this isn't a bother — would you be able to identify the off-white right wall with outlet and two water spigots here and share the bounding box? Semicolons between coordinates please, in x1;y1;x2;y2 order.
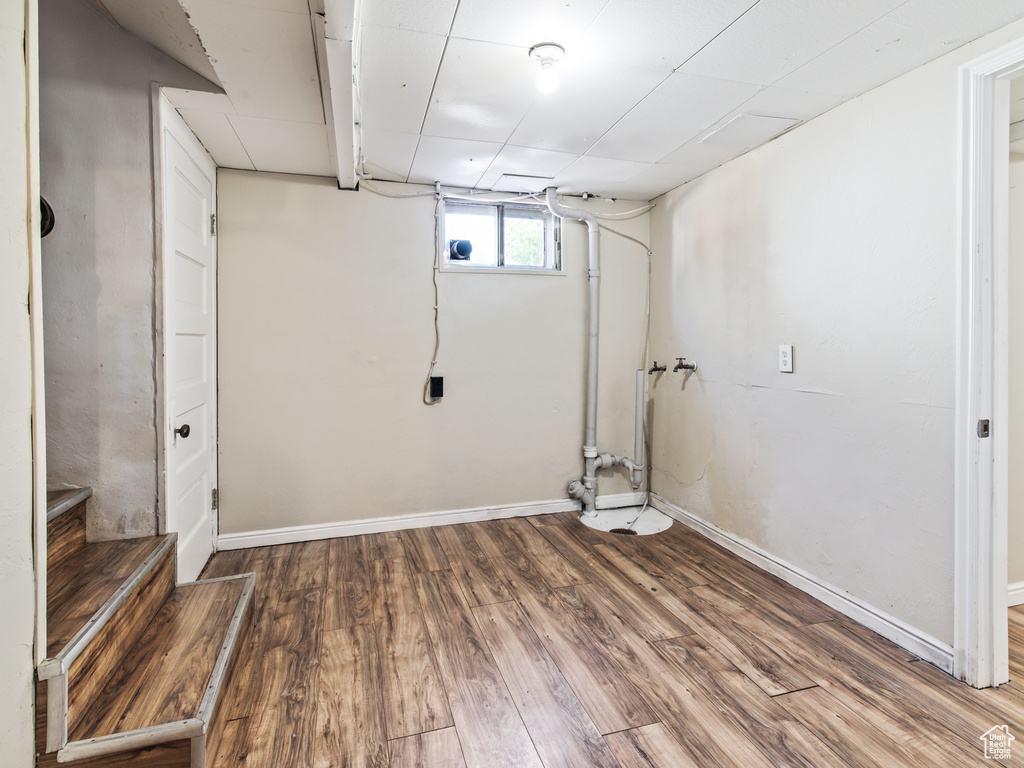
651;18;1024;643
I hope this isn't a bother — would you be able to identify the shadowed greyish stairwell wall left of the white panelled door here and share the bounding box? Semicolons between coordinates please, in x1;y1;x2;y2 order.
40;0;216;539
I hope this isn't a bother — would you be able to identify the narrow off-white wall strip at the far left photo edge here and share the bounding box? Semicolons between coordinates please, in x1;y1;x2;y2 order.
0;2;36;768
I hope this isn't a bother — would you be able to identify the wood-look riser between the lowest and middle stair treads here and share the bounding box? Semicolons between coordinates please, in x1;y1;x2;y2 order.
68;547;176;733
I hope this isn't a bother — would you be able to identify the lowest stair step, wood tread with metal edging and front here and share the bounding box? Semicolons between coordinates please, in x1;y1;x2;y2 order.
48;573;256;768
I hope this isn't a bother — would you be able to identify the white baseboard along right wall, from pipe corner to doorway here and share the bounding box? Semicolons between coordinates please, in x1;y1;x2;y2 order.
651;494;954;674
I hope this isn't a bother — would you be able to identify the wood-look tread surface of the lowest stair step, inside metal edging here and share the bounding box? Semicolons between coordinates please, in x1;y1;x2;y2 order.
70;579;247;741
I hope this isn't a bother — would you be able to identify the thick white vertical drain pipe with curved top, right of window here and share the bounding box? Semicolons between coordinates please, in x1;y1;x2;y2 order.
547;186;601;515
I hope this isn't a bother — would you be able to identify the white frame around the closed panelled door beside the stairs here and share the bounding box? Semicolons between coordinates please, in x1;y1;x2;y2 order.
152;91;219;551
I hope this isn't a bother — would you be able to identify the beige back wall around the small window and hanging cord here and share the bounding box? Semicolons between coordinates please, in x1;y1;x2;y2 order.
218;169;648;534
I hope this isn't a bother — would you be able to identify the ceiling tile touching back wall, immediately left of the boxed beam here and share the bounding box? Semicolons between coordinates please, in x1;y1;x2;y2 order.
227;115;335;176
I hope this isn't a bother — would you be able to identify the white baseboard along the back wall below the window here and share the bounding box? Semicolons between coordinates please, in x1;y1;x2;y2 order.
217;494;585;550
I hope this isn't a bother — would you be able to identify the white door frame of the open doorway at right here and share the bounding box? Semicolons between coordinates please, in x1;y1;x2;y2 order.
953;34;1024;688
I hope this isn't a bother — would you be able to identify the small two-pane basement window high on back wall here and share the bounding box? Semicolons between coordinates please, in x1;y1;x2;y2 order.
440;199;562;273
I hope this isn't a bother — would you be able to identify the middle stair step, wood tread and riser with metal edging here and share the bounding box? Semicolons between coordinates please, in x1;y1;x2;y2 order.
37;536;177;753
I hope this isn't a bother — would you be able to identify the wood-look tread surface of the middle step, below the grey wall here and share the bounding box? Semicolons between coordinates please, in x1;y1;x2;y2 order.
46;536;167;658
